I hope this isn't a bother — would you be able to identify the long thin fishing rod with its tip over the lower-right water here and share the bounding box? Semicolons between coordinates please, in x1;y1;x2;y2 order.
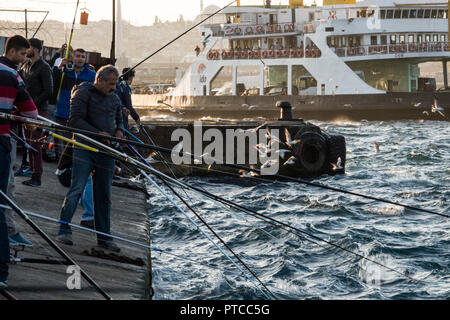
28;116;420;282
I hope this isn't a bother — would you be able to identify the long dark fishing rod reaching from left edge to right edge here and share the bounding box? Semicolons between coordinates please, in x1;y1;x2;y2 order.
0;113;444;218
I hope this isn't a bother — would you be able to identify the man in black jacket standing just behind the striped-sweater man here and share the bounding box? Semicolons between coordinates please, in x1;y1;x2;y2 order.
21;39;53;187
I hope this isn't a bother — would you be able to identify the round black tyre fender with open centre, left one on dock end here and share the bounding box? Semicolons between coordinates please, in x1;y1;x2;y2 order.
294;131;328;175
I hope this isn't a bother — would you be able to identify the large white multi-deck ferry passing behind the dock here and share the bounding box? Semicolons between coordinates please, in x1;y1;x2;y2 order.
134;0;450;120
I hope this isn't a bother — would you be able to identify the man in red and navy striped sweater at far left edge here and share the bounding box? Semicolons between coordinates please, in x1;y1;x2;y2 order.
0;36;38;288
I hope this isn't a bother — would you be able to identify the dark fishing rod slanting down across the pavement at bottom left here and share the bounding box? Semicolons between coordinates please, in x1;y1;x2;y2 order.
0;190;112;300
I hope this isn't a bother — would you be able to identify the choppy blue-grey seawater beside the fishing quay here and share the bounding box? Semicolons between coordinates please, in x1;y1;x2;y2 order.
148;121;450;300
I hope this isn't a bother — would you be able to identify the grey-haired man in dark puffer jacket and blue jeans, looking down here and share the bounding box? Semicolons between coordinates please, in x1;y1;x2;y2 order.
56;65;123;252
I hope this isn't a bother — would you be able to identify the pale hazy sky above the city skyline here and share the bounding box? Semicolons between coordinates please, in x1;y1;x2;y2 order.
0;0;322;26
